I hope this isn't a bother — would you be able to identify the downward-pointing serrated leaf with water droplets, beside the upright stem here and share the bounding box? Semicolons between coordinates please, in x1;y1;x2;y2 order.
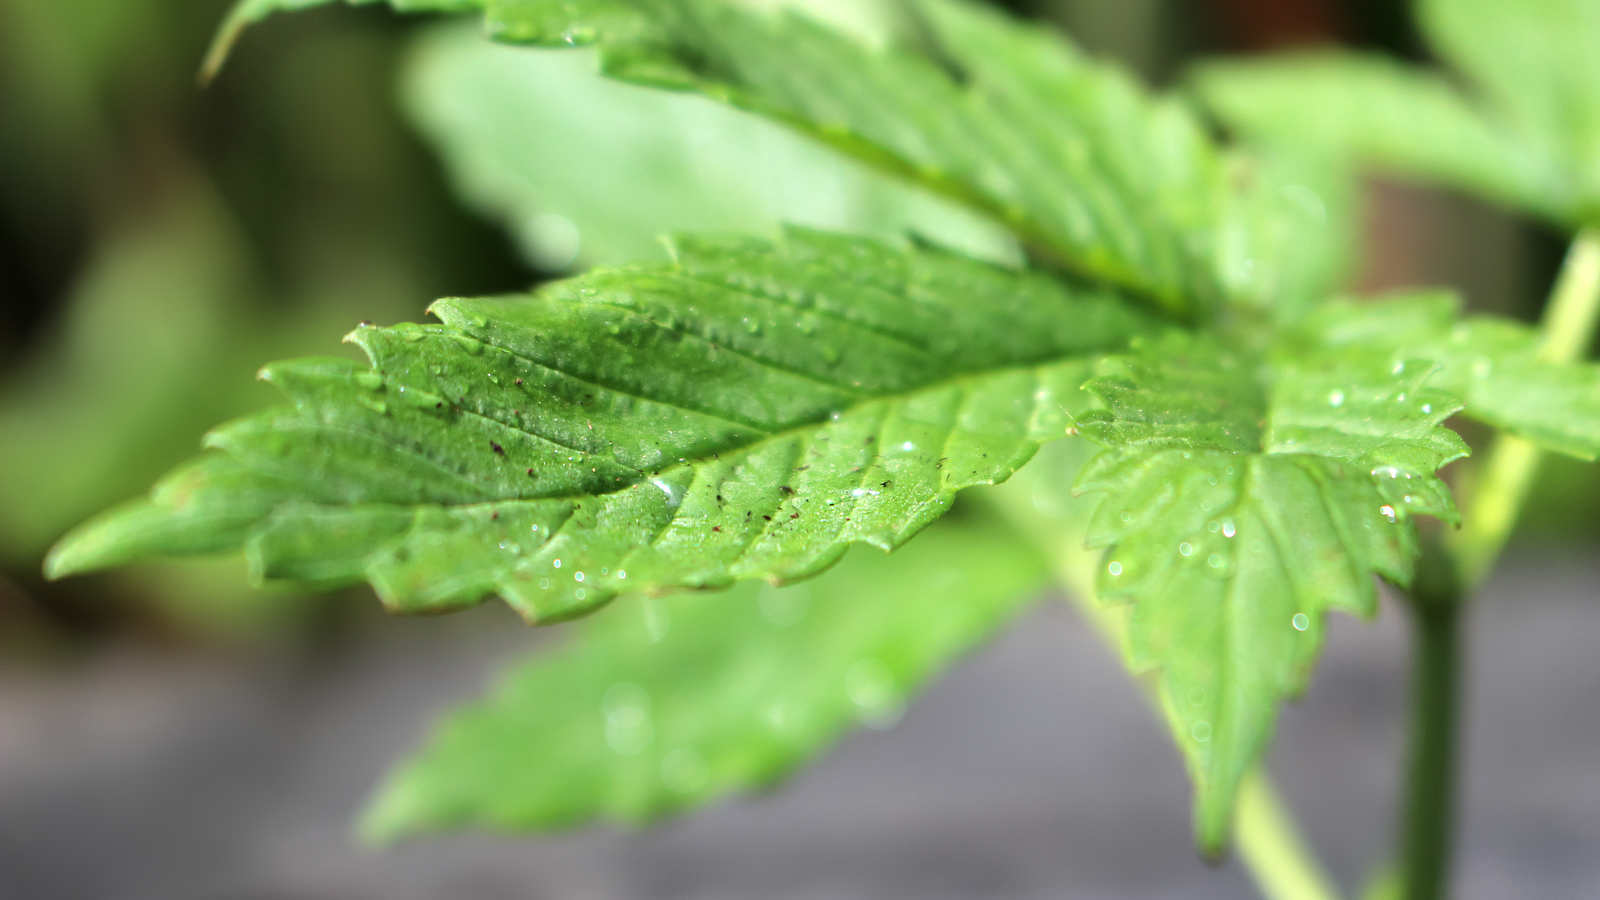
1075;335;1466;852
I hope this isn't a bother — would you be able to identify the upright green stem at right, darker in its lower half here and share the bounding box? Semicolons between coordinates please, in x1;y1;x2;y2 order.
1402;229;1600;900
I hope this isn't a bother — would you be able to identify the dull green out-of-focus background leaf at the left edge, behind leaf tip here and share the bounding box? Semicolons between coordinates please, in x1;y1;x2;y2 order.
0;186;250;564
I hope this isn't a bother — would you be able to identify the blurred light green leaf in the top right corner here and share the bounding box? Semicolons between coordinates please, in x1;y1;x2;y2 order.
1197;0;1600;226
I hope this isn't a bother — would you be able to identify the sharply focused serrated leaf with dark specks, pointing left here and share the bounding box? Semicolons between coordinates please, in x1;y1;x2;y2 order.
46;231;1152;621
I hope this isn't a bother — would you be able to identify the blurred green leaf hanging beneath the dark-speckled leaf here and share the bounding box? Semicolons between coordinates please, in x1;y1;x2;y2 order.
363;514;1046;839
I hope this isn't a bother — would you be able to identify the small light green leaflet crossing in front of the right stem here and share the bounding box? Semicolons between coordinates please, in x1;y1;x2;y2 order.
1298;291;1600;460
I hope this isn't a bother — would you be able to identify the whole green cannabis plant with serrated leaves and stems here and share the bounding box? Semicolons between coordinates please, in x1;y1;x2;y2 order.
46;0;1600;898
